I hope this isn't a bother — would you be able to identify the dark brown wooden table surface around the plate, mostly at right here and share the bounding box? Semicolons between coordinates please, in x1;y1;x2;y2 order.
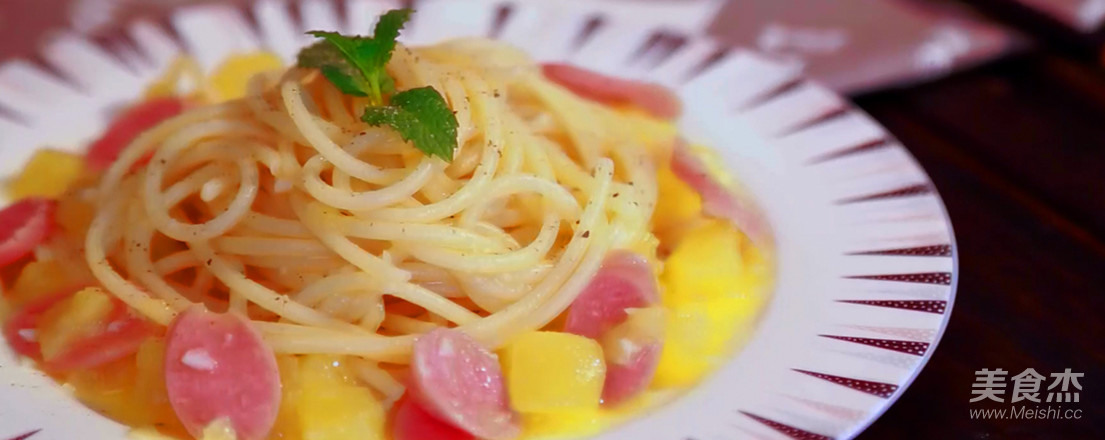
0;0;1105;440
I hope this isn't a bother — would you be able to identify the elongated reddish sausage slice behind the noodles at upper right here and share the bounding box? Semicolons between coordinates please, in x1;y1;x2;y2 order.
541;63;683;119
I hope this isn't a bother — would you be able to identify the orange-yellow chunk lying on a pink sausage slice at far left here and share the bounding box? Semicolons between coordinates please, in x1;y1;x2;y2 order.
38;287;115;362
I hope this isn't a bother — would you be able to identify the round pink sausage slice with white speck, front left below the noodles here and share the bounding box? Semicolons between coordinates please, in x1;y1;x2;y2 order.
165;307;281;440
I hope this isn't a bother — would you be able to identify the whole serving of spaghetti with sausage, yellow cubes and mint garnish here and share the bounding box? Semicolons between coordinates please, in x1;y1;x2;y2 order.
0;10;770;440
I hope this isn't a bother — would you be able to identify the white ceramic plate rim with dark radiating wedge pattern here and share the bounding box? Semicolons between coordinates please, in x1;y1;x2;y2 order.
0;0;956;440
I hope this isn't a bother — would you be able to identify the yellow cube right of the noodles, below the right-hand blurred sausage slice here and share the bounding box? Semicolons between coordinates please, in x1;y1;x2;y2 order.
661;220;748;307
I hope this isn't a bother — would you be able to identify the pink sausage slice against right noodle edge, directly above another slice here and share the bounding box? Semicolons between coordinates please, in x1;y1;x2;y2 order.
564;251;660;338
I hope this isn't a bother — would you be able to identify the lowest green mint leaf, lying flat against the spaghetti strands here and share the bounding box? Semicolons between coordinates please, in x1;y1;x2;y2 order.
361;86;459;161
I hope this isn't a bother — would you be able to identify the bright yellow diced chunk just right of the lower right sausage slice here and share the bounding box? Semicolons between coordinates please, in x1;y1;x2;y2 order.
653;295;764;387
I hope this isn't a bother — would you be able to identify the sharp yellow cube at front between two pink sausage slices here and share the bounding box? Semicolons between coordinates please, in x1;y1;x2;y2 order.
505;332;607;412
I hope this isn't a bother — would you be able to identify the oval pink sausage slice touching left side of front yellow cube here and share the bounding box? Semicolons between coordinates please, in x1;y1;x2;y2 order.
411;328;522;440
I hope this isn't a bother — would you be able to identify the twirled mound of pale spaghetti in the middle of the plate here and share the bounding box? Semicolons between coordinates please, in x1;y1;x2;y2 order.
85;40;674;364
